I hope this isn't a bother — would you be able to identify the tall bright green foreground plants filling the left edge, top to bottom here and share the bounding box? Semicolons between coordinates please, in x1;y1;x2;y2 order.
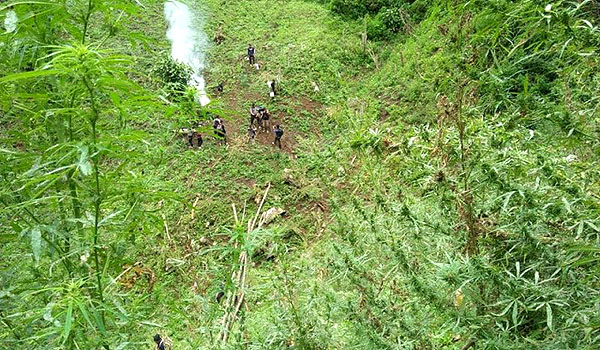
0;1;169;349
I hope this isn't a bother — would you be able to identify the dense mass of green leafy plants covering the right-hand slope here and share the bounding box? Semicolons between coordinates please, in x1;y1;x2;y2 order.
332;1;599;349
